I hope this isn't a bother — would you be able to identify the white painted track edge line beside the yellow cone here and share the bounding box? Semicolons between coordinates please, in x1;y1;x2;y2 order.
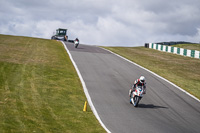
62;41;111;133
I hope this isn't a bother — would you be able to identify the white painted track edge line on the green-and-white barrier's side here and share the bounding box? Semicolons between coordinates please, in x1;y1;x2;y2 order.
102;48;200;102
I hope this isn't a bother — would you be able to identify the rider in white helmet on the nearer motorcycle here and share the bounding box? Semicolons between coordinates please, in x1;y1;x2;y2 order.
129;76;146;97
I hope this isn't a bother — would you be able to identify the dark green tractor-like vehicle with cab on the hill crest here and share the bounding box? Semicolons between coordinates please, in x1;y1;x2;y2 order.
51;28;68;41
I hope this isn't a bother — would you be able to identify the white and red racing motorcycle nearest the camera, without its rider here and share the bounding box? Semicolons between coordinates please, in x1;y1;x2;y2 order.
129;86;144;107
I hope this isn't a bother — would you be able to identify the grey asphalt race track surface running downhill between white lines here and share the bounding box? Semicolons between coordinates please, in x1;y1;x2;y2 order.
65;42;200;133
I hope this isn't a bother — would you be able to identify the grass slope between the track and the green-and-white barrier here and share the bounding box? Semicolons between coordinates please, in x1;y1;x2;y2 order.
104;45;200;99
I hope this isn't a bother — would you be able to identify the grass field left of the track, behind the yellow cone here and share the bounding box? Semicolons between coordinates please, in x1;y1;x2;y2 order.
0;35;105;133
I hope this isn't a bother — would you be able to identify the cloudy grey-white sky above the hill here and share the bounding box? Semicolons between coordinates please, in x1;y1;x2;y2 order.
0;0;200;46
